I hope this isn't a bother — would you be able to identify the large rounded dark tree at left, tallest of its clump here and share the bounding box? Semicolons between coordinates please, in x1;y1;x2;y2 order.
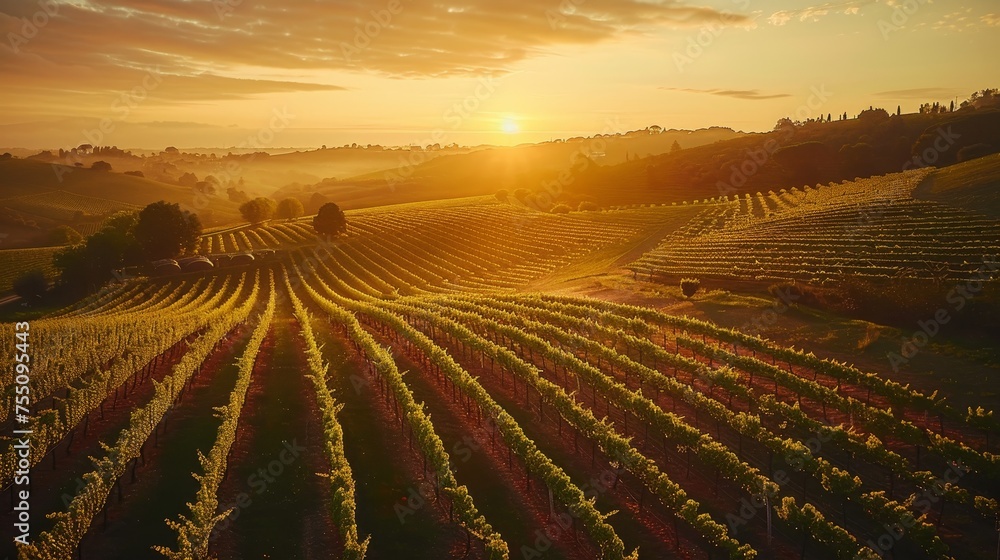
134;200;201;260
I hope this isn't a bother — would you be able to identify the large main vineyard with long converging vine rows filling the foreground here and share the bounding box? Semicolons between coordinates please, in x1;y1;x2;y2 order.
0;189;1000;559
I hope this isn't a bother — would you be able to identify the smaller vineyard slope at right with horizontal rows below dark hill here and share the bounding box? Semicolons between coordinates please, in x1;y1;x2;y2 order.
632;170;1000;283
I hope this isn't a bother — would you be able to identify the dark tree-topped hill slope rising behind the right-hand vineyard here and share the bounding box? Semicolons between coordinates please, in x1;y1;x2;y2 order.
570;109;1000;204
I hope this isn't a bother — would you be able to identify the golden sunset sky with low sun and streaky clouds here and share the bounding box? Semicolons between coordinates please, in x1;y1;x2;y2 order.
0;0;1000;149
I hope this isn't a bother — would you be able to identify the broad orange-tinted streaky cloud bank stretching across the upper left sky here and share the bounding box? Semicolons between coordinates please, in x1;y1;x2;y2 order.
0;0;752;81
